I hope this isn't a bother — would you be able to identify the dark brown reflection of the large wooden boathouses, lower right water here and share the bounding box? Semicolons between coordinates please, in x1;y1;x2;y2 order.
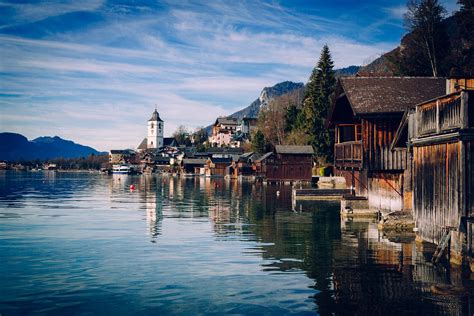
333;221;472;315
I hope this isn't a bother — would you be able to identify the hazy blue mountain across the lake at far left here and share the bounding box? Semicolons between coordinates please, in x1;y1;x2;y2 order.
0;133;104;161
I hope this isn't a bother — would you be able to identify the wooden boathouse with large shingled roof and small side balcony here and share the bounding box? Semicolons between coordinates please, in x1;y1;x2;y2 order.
327;77;446;213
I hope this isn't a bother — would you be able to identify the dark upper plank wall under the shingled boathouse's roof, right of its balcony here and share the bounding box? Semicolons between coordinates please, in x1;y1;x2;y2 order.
362;116;407;171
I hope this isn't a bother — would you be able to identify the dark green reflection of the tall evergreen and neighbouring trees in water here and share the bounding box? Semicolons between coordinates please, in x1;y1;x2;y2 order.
244;186;340;314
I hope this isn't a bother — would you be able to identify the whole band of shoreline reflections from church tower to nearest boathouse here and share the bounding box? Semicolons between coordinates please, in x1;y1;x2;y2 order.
131;177;469;315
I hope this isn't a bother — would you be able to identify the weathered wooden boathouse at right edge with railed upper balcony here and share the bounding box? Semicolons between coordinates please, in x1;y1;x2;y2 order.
393;79;474;263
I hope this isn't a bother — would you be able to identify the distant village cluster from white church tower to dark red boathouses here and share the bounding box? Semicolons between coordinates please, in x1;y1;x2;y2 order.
110;109;314;184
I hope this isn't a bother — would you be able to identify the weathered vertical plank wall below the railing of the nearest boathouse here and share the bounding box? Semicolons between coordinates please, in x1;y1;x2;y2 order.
413;142;462;243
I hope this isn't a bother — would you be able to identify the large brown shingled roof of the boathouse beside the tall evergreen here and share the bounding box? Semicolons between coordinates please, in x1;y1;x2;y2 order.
339;77;446;115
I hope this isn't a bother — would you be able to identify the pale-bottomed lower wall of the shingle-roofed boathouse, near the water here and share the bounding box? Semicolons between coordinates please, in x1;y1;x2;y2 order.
368;172;403;213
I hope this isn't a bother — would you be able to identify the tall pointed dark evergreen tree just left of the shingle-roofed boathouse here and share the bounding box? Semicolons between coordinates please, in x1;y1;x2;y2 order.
300;45;336;160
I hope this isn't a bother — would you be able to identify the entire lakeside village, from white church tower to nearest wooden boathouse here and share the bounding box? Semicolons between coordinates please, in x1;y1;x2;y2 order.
110;76;474;270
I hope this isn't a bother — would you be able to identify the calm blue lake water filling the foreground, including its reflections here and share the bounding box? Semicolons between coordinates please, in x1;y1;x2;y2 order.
0;172;474;316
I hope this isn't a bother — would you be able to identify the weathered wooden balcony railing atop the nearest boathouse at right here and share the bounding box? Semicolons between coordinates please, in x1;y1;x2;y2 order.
416;91;469;136
